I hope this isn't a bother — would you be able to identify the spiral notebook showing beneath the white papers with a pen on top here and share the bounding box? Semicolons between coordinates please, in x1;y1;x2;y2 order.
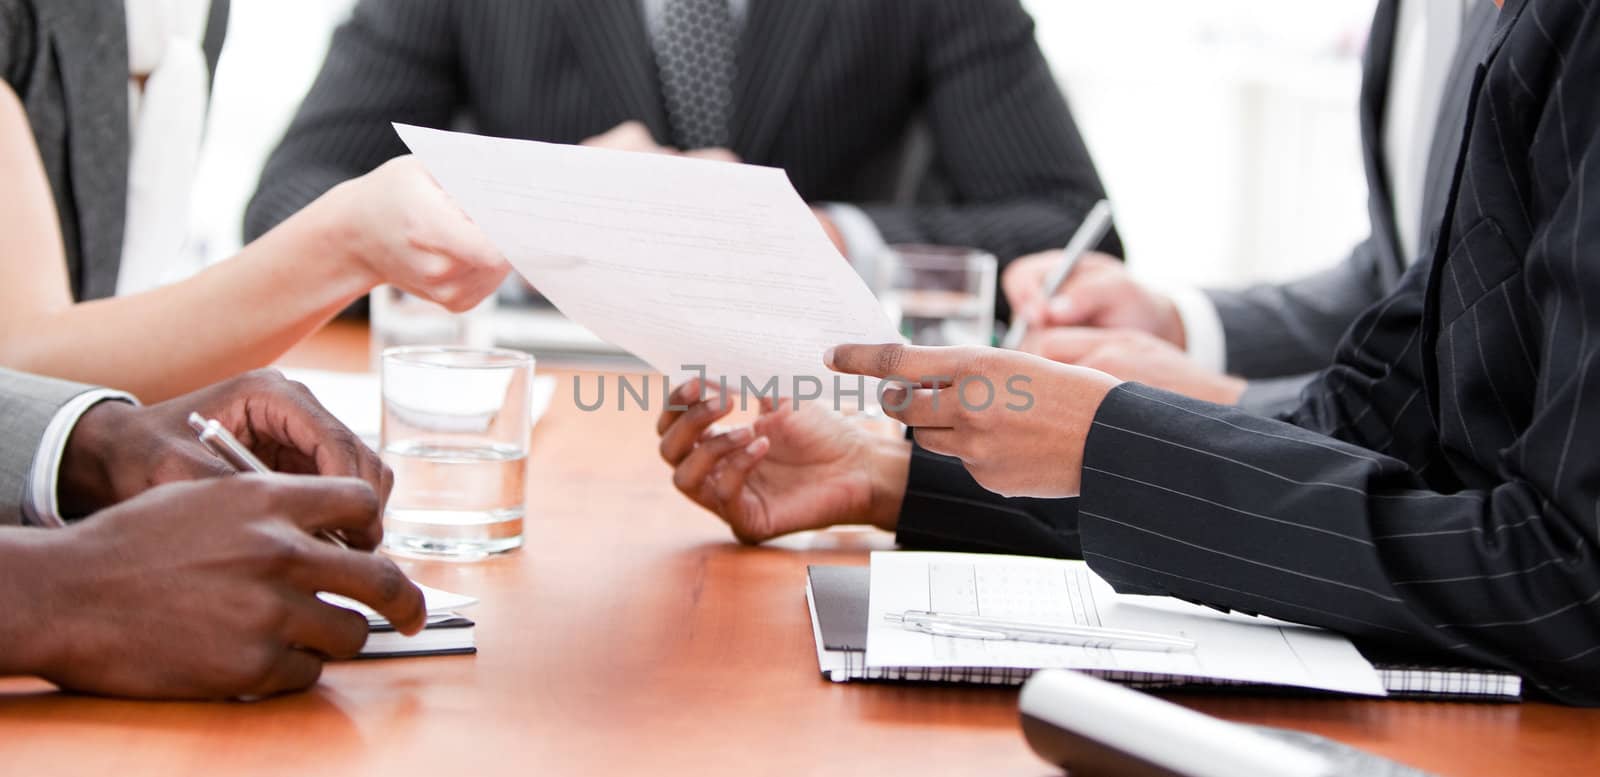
806;566;1522;702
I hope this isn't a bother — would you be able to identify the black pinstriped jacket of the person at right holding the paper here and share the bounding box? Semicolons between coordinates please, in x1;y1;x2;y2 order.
902;0;1600;703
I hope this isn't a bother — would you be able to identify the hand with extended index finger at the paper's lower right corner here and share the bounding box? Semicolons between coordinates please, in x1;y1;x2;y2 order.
826;344;1118;497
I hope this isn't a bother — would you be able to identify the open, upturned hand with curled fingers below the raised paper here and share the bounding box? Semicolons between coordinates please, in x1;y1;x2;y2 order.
656;381;910;544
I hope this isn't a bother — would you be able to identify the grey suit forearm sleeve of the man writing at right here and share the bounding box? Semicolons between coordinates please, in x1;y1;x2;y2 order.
1206;238;1387;380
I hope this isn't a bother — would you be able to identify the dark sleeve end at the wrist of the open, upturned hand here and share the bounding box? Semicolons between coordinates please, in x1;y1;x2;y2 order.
896;446;1080;558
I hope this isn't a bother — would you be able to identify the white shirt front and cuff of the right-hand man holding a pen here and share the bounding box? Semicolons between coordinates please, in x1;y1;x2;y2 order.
1171;0;1485;373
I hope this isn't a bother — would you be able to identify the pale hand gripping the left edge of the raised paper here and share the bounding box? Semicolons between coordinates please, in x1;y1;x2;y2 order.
312;157;510;313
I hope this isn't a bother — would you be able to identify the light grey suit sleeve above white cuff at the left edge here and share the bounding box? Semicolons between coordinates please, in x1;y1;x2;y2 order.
0;369;91;526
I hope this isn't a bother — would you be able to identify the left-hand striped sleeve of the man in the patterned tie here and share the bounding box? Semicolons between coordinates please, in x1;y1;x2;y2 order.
245;0;461;240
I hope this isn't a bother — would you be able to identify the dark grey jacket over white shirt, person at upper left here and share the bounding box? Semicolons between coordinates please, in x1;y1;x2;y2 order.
0;0;229;301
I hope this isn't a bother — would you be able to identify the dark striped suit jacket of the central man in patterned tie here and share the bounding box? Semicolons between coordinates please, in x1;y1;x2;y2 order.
245;0;1104;279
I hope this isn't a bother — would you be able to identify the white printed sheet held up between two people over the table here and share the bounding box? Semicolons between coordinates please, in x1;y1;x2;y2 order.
395;125;901;401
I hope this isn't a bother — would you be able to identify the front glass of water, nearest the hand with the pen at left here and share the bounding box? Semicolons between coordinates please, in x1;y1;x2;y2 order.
381;345;534;561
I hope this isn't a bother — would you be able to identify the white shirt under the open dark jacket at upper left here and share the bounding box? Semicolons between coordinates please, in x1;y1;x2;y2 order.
117;0;211;296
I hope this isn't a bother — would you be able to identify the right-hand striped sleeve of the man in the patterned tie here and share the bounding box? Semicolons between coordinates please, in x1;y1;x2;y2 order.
864;0;1122;262
